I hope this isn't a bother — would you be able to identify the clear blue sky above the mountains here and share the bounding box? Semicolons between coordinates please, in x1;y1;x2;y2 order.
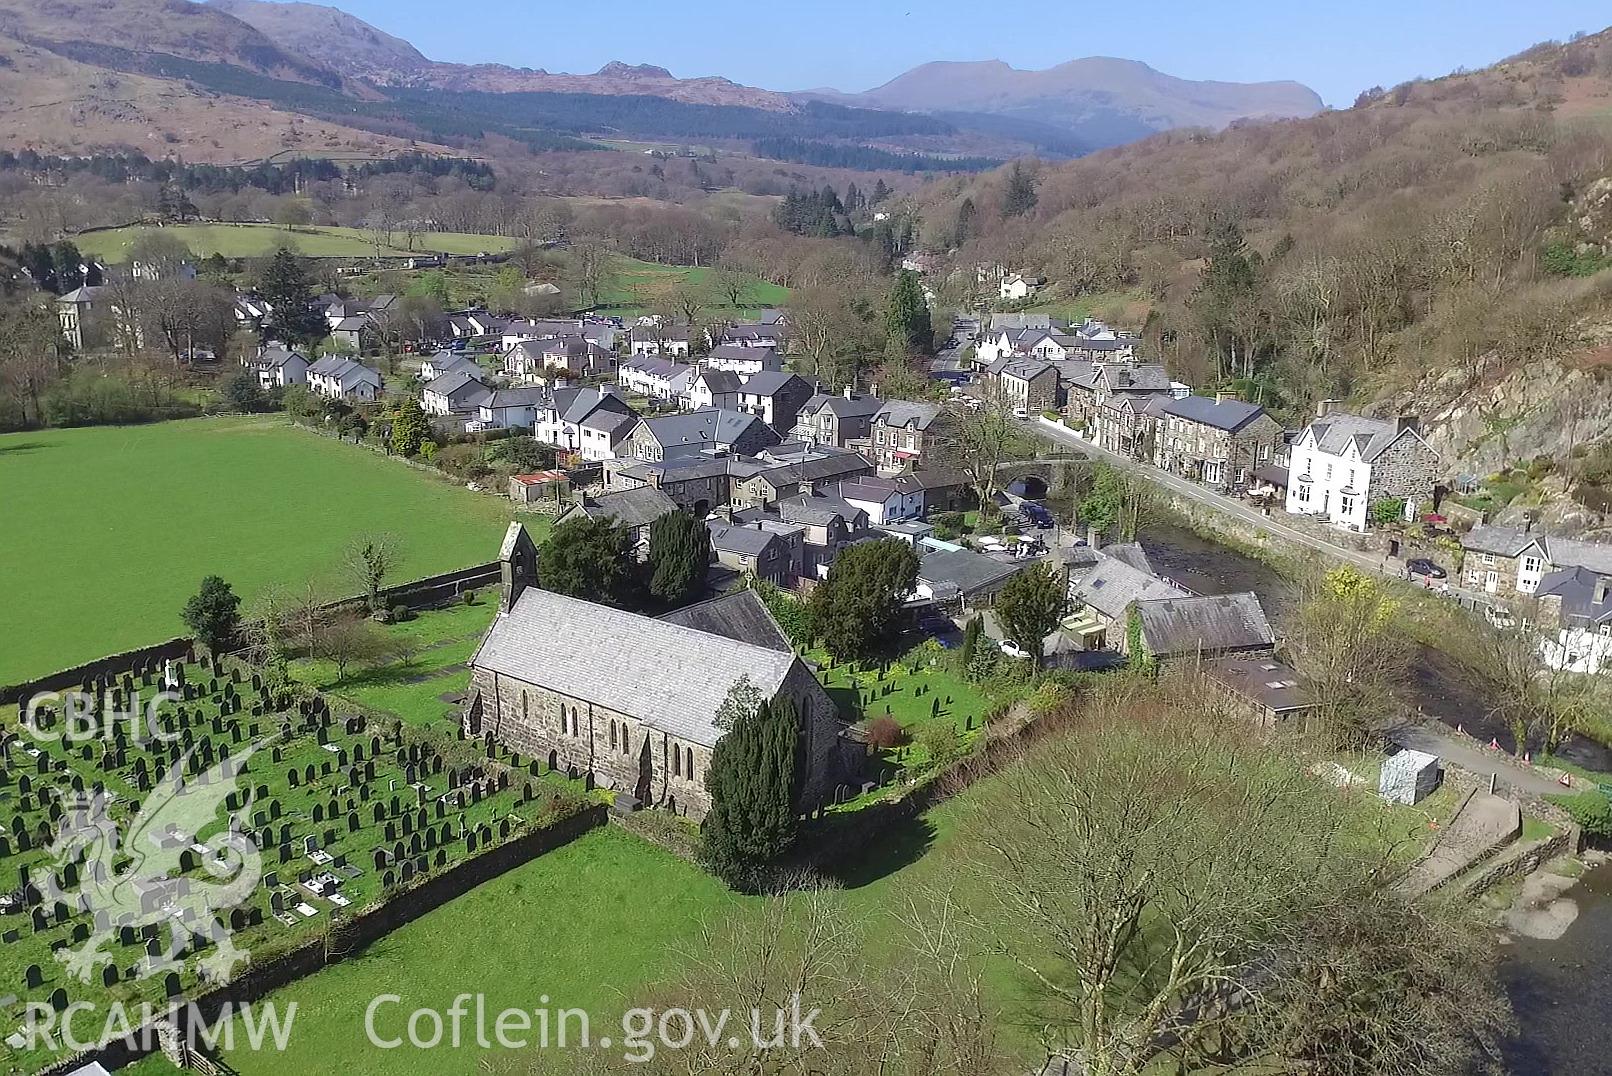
311;0;1612;105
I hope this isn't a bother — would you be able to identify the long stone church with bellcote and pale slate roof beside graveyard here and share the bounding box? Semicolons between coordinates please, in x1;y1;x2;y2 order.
464;523;854;820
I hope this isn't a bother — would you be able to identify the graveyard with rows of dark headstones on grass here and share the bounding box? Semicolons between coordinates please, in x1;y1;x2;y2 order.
0;645;592;1068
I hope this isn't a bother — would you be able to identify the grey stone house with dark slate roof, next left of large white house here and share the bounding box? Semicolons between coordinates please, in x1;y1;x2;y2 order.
1153;392;1282;490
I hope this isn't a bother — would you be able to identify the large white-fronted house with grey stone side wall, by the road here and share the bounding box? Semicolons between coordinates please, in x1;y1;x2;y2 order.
1286;400;1444;532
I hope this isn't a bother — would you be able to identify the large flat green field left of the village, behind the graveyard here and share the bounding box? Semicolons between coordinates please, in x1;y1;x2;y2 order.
0;416;511;690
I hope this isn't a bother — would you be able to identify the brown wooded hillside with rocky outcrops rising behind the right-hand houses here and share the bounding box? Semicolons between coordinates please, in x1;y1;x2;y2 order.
914;31;1612;524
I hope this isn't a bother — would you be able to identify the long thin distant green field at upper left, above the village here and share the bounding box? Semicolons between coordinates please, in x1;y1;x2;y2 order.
74;224;514;261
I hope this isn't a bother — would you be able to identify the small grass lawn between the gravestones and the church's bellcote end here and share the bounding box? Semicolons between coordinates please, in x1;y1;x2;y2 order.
292;603;498;731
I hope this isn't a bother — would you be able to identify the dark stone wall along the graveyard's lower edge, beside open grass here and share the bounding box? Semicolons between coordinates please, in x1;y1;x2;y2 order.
39;805;608;1076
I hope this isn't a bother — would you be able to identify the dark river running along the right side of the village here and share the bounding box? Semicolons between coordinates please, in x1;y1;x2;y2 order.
1140;524;1612;1076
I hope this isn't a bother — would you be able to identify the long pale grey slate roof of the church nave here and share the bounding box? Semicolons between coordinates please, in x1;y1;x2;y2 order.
471;587;796;747
